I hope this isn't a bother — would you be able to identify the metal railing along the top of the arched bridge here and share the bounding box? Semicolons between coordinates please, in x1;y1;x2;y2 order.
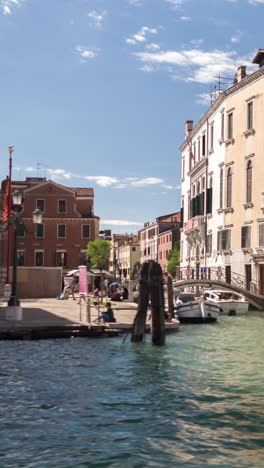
176;266;263;294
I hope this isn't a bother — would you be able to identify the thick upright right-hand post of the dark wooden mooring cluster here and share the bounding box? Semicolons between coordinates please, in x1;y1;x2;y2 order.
149;262;165;346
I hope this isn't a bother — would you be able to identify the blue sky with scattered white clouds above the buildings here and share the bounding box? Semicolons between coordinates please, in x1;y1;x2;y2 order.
0;0;264;233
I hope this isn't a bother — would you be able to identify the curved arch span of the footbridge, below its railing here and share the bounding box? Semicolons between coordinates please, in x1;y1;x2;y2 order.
173;279;264;311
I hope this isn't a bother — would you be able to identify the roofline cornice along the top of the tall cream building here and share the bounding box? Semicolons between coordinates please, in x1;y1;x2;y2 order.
179;67;264;151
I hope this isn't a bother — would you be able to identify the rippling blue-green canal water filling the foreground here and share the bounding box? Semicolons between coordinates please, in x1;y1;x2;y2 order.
0;314;264;468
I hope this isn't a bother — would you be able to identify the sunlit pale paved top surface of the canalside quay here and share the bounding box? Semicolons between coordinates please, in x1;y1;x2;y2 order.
0;297;137;328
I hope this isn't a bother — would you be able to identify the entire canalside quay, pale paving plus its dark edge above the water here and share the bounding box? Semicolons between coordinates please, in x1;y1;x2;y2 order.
0;299;180;340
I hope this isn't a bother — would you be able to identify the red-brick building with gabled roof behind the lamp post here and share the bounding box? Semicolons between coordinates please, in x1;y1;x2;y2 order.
1;177;99;269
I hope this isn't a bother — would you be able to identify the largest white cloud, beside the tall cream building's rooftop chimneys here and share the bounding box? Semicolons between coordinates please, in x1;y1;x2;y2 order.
134;49;253;83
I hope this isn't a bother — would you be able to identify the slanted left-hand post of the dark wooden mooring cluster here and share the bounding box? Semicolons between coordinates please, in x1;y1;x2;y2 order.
131;262;150;343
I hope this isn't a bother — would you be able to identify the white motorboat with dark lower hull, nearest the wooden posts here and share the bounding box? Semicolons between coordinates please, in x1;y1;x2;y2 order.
175;293;222;323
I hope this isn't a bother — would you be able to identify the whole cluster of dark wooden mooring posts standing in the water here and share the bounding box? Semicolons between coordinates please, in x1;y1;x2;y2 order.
131;262;165;346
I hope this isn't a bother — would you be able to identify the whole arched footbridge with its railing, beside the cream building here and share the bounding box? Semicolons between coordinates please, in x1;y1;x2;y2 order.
173;267;264;310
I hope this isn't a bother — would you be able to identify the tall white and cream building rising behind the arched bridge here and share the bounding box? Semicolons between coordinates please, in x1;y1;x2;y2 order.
180;49;264;293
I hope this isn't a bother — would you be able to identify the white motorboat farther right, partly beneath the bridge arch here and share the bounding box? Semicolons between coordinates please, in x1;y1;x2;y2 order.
204;289;248;315
